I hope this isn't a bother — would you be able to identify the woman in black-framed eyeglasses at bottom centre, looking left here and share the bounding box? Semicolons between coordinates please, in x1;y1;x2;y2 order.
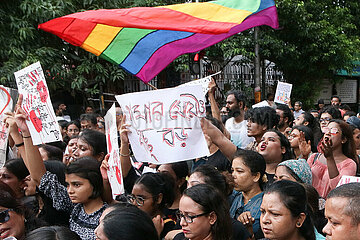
174;184;232;240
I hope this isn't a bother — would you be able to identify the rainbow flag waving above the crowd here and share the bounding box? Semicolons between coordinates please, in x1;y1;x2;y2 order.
39;0;278;83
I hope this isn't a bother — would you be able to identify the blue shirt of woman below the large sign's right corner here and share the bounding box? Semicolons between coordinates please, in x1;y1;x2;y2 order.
230;190;264;233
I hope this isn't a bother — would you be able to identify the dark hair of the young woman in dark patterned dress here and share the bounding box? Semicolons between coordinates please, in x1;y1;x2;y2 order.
65;157;103;199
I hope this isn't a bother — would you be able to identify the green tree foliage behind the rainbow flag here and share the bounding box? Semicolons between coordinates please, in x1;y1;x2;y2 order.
0;0;360;107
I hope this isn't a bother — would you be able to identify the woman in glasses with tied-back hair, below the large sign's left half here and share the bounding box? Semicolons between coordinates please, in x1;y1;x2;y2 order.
127;173;175;238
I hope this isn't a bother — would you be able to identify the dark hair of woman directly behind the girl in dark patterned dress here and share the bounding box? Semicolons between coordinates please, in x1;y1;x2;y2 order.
79;129;107;156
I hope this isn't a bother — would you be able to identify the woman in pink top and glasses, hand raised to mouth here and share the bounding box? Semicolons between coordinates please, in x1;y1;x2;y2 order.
307;119;358;198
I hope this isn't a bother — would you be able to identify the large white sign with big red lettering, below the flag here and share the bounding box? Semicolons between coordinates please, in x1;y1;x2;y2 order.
116;85;209;164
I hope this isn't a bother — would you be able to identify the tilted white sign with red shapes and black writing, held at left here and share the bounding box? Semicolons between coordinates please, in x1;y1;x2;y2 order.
14;62;62;145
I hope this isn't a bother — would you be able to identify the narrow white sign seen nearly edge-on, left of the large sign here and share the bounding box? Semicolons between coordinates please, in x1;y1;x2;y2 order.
104;103;124;199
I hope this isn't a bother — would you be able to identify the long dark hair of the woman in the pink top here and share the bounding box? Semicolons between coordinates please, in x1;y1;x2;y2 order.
329;119;358;164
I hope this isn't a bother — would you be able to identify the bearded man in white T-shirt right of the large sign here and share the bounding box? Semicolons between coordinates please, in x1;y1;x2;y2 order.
225;90;254;148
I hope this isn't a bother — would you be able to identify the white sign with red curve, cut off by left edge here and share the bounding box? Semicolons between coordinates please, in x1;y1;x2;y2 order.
0;85;13;167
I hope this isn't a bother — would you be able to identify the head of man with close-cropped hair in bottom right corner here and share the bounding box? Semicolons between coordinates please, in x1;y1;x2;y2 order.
323;183;360;240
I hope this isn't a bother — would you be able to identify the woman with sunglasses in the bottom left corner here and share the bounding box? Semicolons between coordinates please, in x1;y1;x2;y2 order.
0;181;42;240
